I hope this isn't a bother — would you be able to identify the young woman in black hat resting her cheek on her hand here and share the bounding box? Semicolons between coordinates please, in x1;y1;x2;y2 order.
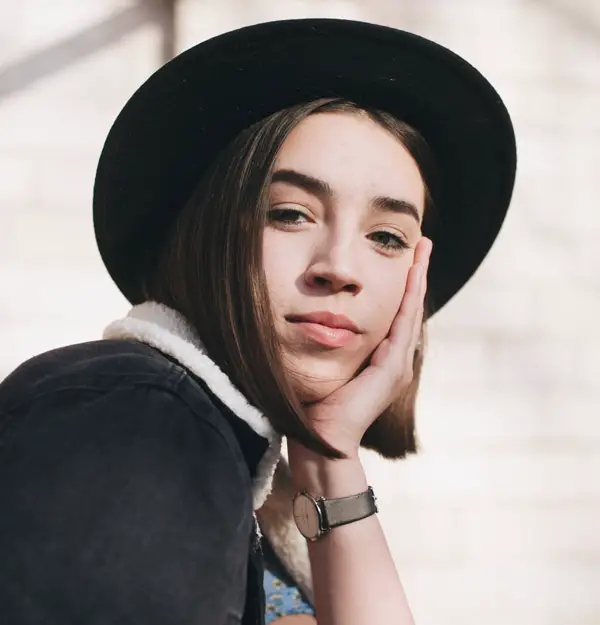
0;20;515;625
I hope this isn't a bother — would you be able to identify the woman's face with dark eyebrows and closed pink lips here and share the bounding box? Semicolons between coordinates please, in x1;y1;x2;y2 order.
263;113;425;401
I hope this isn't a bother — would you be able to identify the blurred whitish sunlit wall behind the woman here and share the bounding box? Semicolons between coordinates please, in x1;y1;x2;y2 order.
0;0;600;625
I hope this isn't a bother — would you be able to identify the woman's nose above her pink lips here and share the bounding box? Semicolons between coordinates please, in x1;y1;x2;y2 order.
304;245;363;295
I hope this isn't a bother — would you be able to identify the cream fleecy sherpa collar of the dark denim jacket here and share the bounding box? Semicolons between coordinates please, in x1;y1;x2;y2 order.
103;302;312;601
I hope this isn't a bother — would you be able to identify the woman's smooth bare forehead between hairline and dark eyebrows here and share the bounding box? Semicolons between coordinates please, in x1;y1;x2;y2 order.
275;113;425;209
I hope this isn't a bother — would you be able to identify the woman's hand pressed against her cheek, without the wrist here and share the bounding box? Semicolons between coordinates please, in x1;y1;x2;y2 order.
306;237;432;458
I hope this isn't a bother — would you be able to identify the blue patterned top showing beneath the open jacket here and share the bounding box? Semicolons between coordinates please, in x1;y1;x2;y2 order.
263;538;315;625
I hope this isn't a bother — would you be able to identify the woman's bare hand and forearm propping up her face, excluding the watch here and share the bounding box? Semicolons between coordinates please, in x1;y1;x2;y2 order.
288;238;431;625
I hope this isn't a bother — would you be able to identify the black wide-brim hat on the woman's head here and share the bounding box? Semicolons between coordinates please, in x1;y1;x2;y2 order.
94;19;516;314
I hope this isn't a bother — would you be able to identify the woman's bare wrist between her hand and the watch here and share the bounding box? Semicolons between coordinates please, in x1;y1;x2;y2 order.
288;441;368;499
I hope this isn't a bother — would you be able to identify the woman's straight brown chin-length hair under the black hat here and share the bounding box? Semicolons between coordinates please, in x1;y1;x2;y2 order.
146;99;431;458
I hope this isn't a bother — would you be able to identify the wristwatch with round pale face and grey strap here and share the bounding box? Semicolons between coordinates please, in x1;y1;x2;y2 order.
293;486;377;541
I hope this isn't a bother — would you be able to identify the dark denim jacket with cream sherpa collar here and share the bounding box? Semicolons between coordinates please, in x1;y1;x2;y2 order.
0;303;310;625
